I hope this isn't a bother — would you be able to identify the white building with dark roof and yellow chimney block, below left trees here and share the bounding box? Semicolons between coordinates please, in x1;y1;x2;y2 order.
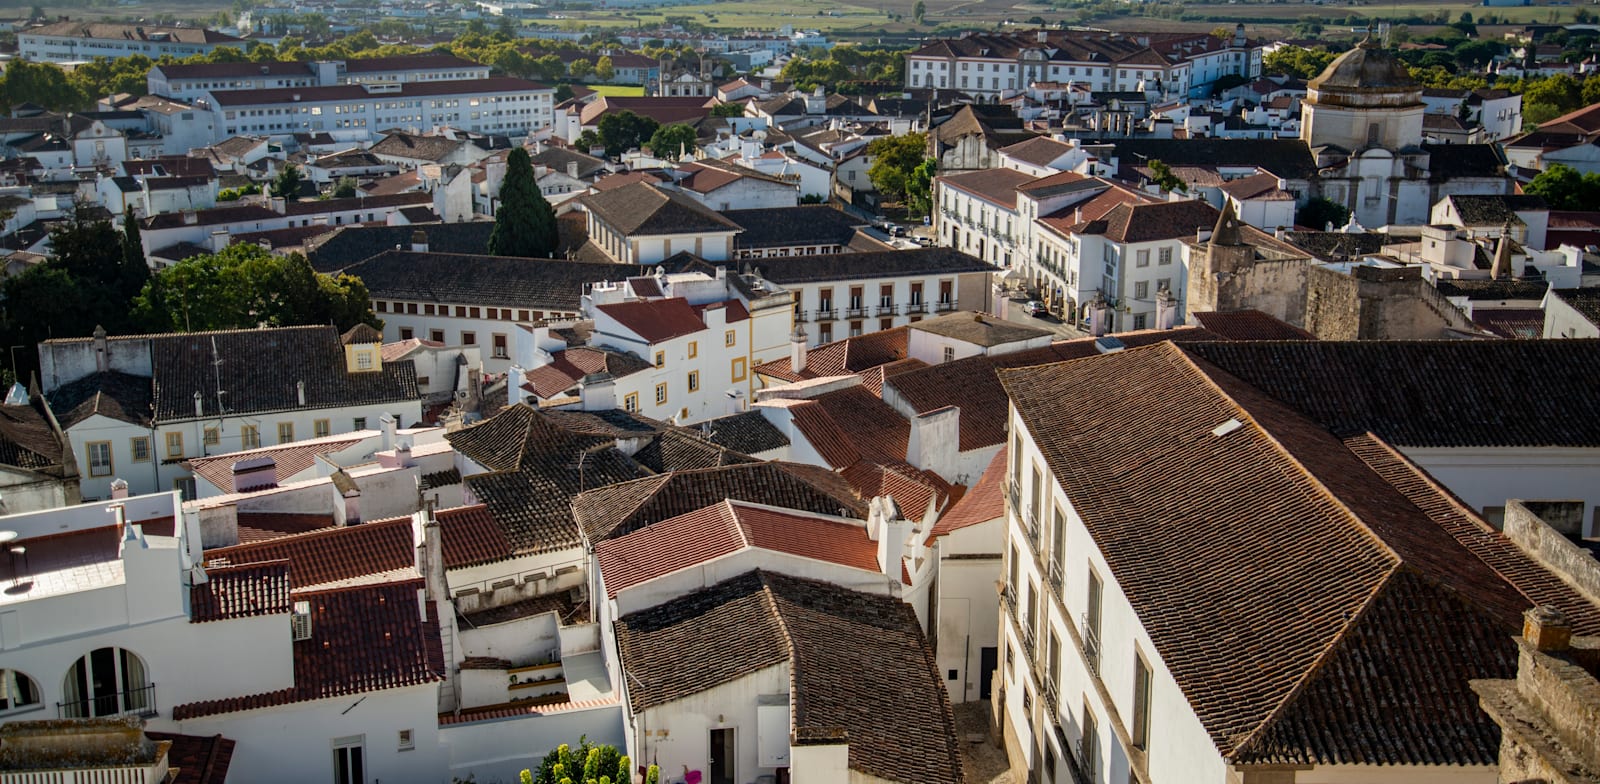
38;326;422;498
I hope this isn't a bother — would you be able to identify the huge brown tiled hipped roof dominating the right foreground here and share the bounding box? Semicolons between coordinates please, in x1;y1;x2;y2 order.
1002;342;1600;765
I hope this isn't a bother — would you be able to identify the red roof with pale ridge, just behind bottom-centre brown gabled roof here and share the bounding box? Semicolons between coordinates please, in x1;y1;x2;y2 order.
595;501;878;598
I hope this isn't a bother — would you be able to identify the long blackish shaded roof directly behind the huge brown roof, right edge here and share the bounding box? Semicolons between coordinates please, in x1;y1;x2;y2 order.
1186;341;1600;446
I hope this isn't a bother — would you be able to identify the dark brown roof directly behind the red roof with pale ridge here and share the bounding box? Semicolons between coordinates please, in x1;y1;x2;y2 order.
571;462;866;542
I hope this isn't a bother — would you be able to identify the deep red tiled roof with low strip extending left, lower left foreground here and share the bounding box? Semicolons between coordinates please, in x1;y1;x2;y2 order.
173;579;445;722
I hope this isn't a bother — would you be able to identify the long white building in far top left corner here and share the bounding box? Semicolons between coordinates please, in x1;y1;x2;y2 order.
16;22;246;62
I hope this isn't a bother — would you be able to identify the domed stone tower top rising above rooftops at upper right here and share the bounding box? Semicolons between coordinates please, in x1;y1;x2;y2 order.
1301;35;1422;152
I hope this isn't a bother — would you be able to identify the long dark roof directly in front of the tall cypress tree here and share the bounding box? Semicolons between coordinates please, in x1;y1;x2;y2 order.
346;250;653;312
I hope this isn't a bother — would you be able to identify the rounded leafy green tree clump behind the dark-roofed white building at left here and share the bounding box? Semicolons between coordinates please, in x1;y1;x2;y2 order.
133;243;381;333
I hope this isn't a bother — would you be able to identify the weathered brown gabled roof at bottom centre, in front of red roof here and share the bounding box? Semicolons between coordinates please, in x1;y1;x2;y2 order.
616;571;962;784
